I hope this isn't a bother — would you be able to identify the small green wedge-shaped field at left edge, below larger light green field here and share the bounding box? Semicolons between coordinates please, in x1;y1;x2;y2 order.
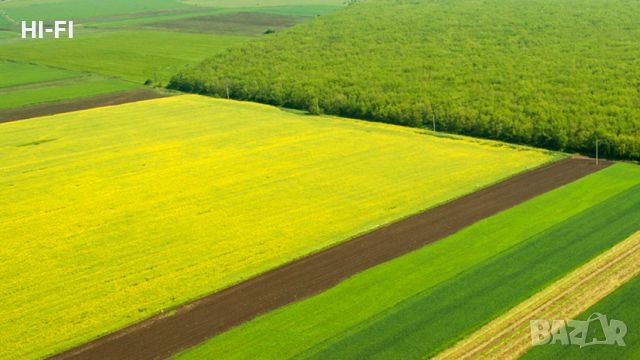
0;61;86;88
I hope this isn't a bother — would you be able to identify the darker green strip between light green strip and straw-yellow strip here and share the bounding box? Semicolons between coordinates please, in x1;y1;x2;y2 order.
302;179;640;359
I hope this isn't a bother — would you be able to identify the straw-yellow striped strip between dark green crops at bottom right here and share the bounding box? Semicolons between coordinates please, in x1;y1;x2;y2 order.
436;232;640;359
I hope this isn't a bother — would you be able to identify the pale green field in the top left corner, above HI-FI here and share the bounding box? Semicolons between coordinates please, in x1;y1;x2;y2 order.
0;0;191;22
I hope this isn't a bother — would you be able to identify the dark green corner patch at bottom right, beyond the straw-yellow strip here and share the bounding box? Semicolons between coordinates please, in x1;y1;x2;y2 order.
520;276;640;360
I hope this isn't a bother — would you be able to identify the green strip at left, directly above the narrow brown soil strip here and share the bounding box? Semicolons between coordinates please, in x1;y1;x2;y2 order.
0;80;142;109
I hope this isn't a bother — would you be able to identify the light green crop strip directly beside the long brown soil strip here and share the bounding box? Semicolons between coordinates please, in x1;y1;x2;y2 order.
175;164;640;359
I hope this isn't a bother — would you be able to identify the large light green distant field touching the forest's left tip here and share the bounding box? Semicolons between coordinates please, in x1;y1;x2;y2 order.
0;31;250;84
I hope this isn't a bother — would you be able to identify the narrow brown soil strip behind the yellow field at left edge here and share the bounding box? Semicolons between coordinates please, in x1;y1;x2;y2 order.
0;89;170;124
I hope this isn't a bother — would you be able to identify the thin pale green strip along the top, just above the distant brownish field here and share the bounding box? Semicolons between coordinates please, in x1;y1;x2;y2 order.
82;5;342;28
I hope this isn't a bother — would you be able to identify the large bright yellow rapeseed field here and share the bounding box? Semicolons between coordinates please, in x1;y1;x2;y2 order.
0;96;558;359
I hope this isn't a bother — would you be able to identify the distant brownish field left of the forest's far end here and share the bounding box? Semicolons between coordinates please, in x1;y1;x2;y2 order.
135;12;310;36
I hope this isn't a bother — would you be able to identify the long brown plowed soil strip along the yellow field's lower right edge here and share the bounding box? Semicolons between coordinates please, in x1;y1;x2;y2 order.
52;159;611;360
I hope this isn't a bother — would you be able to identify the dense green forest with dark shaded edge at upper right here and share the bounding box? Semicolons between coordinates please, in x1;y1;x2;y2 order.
169;0;640;160
